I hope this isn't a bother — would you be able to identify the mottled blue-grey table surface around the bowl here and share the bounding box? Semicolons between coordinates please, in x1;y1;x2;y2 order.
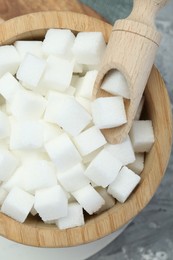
82;0;173;260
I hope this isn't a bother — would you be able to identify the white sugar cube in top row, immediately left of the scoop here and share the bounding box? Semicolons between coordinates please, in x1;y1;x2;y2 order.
72;32;106;64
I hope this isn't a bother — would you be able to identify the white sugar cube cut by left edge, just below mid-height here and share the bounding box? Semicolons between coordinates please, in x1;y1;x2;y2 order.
0;148;19;181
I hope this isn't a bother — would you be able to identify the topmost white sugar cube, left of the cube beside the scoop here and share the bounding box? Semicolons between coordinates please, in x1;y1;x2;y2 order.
42;29;75;56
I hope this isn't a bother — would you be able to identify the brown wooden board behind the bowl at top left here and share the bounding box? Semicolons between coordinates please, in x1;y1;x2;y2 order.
0;0;103;20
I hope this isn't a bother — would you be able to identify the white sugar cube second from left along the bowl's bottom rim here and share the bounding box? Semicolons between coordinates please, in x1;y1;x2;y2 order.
34;185;68;221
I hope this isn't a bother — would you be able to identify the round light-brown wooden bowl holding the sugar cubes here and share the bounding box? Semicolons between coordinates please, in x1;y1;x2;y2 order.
0;12;172;247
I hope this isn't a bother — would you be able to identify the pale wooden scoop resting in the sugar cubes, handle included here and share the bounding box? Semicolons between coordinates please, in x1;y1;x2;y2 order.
93;0;167;144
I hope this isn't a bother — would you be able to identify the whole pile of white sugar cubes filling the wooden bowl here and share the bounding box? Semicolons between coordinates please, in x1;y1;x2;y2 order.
0;29;154;229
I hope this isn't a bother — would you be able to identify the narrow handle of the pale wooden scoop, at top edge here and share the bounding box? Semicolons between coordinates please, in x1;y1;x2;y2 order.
126;0;168;27
